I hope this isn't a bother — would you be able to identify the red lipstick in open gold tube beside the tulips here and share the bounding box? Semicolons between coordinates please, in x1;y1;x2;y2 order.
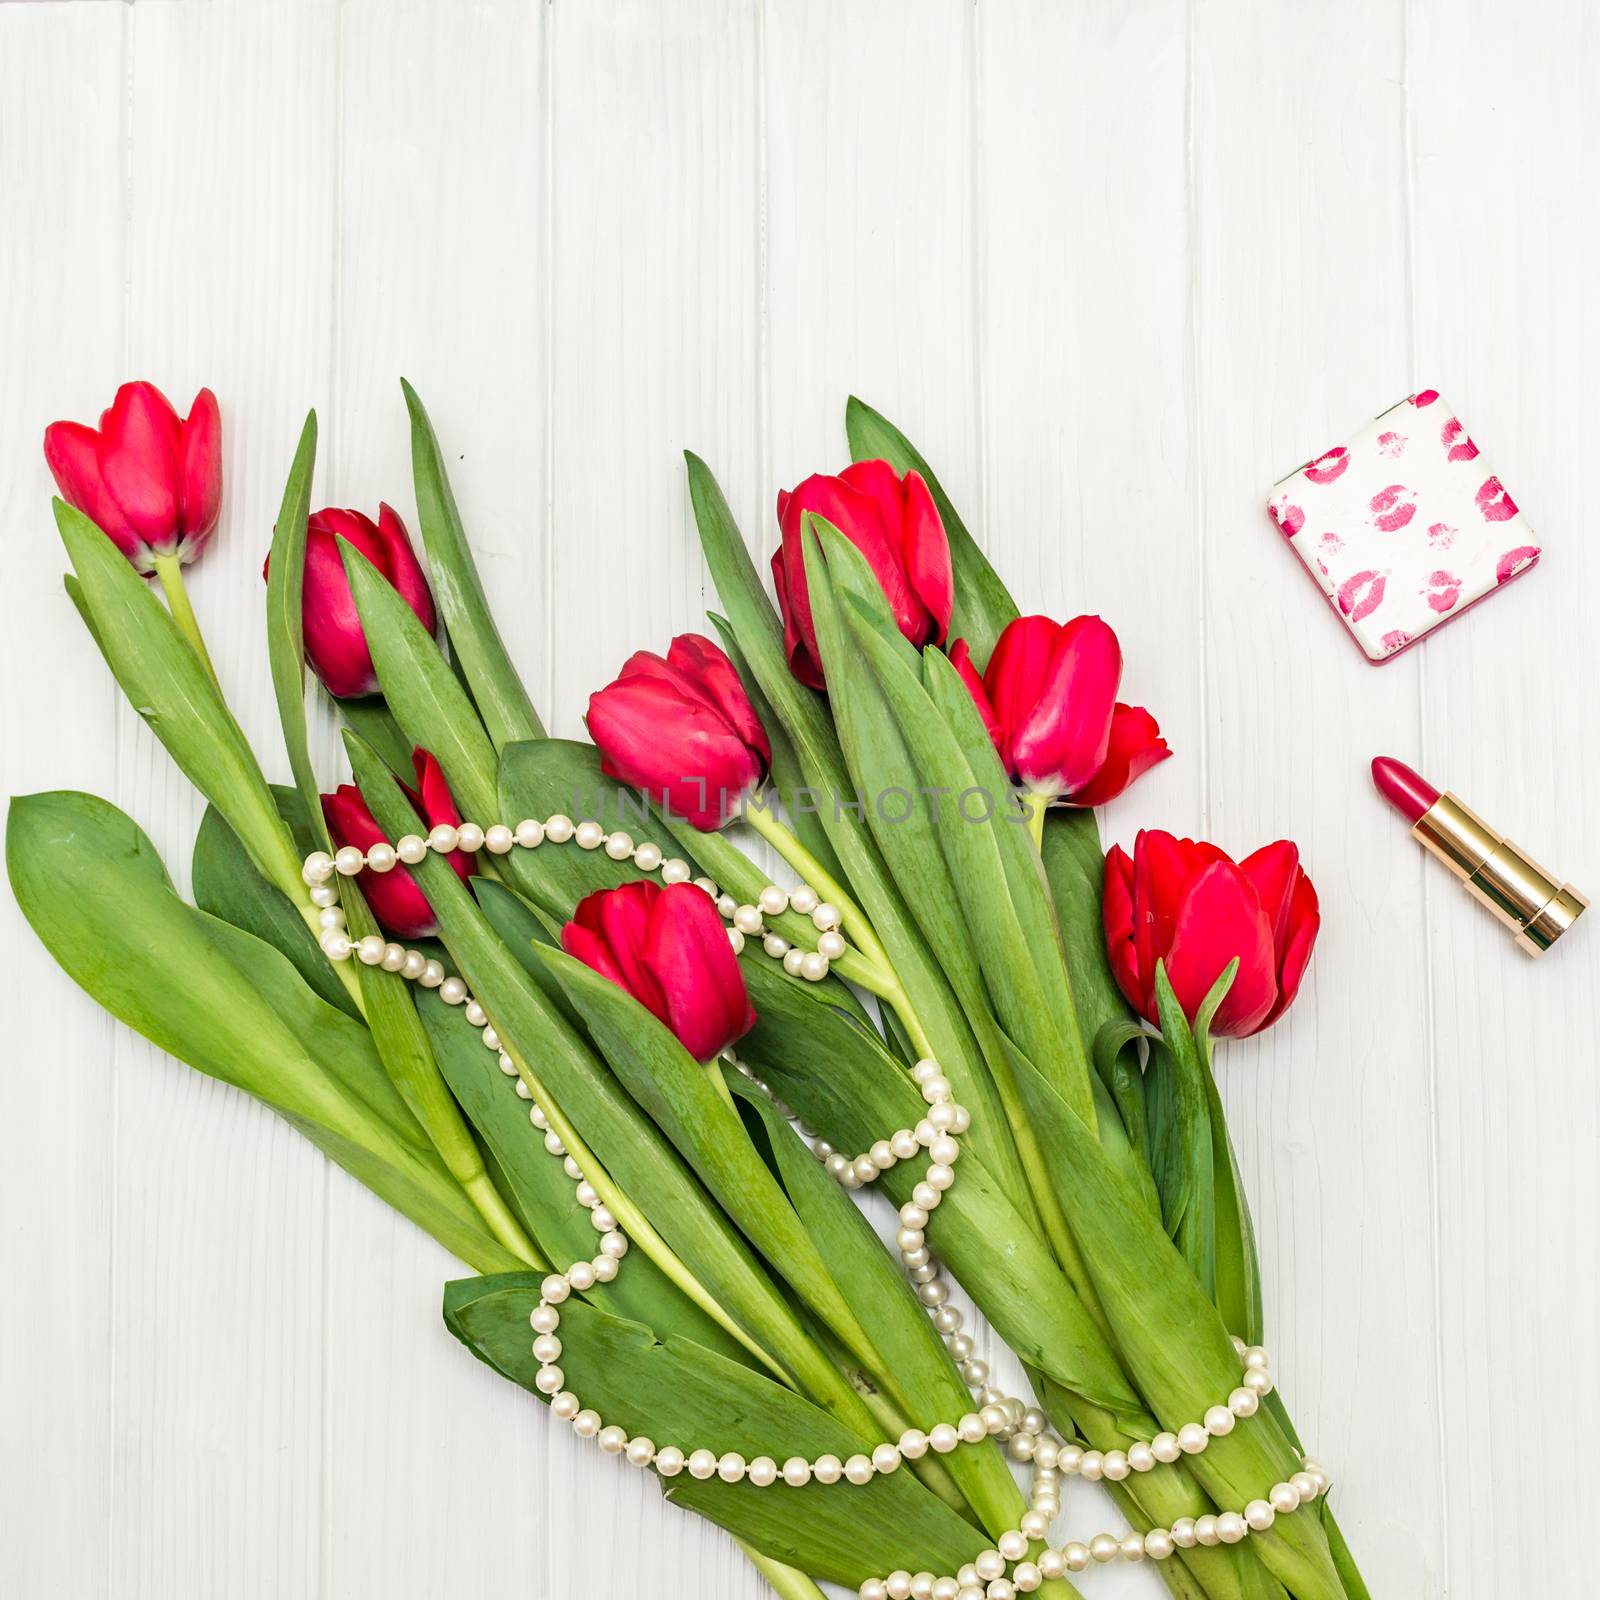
1373;755;1589;955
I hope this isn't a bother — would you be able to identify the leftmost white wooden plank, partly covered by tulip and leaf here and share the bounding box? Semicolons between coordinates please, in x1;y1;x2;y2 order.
0;5;128;1597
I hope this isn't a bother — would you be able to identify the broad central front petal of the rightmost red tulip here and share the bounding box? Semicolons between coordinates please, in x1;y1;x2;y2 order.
1166;859;1278;1038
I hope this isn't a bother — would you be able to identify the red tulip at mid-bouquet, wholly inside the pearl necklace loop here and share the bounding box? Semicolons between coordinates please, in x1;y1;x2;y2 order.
562;880;755;1061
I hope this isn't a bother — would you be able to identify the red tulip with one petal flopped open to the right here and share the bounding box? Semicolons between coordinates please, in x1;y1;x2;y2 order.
950;616;1173;806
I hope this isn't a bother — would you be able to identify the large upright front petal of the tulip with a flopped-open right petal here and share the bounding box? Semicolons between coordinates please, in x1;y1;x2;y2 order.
997;616;1122;794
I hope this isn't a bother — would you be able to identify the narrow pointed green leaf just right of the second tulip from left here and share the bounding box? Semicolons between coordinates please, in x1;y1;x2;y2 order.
400;378;544;750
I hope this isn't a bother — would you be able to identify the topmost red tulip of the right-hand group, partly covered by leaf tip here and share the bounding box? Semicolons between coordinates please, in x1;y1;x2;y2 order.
773;461;955;690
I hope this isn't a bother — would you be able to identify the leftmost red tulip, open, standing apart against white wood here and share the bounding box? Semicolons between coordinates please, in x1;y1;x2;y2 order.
45;382;222;573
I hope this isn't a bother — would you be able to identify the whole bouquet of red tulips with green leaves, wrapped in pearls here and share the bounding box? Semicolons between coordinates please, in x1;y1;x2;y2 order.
6;384;1366;1600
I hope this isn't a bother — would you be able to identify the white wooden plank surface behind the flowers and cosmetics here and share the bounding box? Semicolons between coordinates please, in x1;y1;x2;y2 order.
0;0;1600;1600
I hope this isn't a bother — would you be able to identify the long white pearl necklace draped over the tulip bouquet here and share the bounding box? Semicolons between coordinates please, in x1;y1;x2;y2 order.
301;813;1330;1600
